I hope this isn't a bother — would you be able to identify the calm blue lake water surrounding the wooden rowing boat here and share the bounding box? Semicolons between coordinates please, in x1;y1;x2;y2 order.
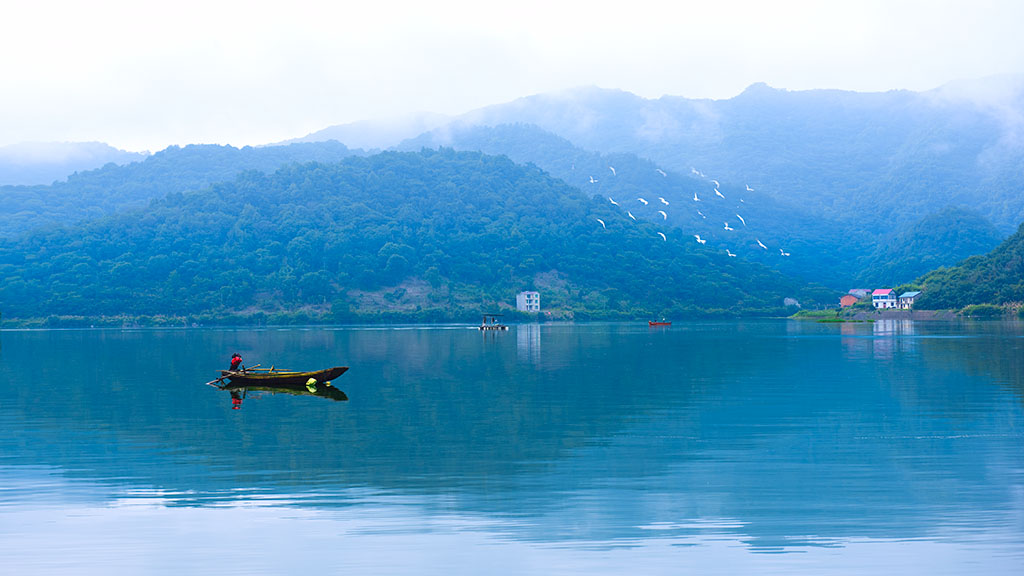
0;321;1024;575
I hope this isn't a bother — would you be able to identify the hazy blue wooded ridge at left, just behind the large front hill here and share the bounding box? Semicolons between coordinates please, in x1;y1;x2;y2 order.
0;141;354;237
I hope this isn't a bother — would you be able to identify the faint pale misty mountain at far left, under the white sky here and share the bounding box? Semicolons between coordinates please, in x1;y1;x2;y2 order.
0;142;148;186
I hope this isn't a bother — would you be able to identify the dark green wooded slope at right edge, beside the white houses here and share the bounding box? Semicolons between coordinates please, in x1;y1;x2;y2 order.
914;219;1024;310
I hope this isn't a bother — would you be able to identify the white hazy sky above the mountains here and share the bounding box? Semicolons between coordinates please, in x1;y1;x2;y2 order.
0;0;1024;152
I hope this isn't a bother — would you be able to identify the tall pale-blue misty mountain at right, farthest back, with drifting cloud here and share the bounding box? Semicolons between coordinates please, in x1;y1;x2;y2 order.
432;77;1024;234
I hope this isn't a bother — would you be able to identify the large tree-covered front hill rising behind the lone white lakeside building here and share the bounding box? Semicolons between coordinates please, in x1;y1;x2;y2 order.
0;150;835;321
